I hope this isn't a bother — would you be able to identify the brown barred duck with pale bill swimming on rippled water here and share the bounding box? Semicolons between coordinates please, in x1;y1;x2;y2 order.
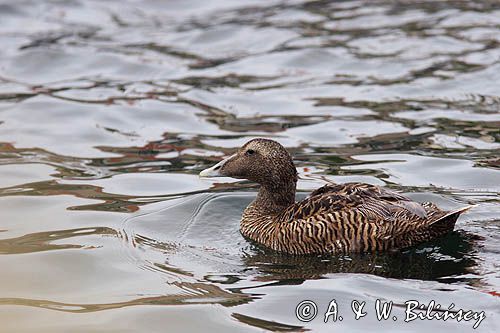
199;138;472;255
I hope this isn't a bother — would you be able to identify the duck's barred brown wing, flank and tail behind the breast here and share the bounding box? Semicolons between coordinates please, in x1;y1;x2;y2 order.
276;183;470;253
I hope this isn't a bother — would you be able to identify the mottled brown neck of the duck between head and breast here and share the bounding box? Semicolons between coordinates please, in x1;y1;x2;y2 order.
253;180;297;215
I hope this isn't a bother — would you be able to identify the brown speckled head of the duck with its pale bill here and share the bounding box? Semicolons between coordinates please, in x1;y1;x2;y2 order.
200;139;297;192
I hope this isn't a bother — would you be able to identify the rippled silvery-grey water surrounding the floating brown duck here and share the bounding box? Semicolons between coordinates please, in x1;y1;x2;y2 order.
0;0;500;332
